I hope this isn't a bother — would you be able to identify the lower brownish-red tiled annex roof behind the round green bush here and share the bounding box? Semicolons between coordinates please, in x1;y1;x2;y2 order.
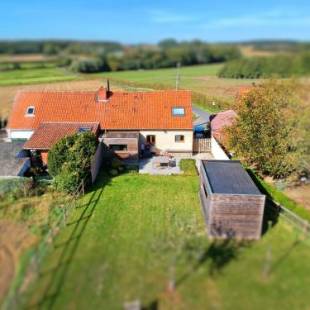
23;123;99;150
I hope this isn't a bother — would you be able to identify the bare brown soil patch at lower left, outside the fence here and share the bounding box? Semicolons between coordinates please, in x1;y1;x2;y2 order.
0;220;36;304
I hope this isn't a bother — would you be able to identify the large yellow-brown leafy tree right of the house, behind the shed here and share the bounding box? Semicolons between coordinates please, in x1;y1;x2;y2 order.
227;81;297;178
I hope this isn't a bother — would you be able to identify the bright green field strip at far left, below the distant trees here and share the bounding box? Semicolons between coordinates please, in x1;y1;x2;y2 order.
0;68;77;86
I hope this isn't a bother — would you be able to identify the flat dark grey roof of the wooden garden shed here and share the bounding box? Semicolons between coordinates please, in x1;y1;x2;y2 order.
202;160;261;195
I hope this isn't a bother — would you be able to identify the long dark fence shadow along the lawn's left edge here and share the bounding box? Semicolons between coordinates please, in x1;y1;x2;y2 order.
26;175;110;309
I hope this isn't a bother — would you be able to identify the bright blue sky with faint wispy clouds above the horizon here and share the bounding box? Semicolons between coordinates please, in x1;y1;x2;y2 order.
0;0;310;43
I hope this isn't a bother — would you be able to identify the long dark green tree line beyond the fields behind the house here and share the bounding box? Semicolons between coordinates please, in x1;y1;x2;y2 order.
0;39;241;73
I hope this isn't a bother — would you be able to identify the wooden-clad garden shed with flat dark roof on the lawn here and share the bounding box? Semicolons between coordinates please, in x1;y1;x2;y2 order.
200;160;265;239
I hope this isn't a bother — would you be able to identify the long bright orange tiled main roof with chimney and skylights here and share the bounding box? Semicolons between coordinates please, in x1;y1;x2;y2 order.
8;88;192;130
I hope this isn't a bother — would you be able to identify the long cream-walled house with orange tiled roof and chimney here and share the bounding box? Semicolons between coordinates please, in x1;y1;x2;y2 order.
7;87;193;162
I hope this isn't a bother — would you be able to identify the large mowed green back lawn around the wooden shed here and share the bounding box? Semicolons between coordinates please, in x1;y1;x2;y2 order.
23;174;310;309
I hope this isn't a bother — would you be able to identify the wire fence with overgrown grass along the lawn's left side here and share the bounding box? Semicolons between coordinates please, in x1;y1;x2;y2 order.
3;180;86;310
